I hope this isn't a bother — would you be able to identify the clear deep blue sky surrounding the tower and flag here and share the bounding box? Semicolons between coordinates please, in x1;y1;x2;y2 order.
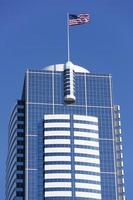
0;0;133;200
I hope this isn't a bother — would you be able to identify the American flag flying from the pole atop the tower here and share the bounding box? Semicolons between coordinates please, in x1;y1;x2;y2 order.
69;14;90;26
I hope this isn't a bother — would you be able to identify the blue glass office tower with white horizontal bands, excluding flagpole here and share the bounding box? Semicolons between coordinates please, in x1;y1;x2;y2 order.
6;62;125;200
